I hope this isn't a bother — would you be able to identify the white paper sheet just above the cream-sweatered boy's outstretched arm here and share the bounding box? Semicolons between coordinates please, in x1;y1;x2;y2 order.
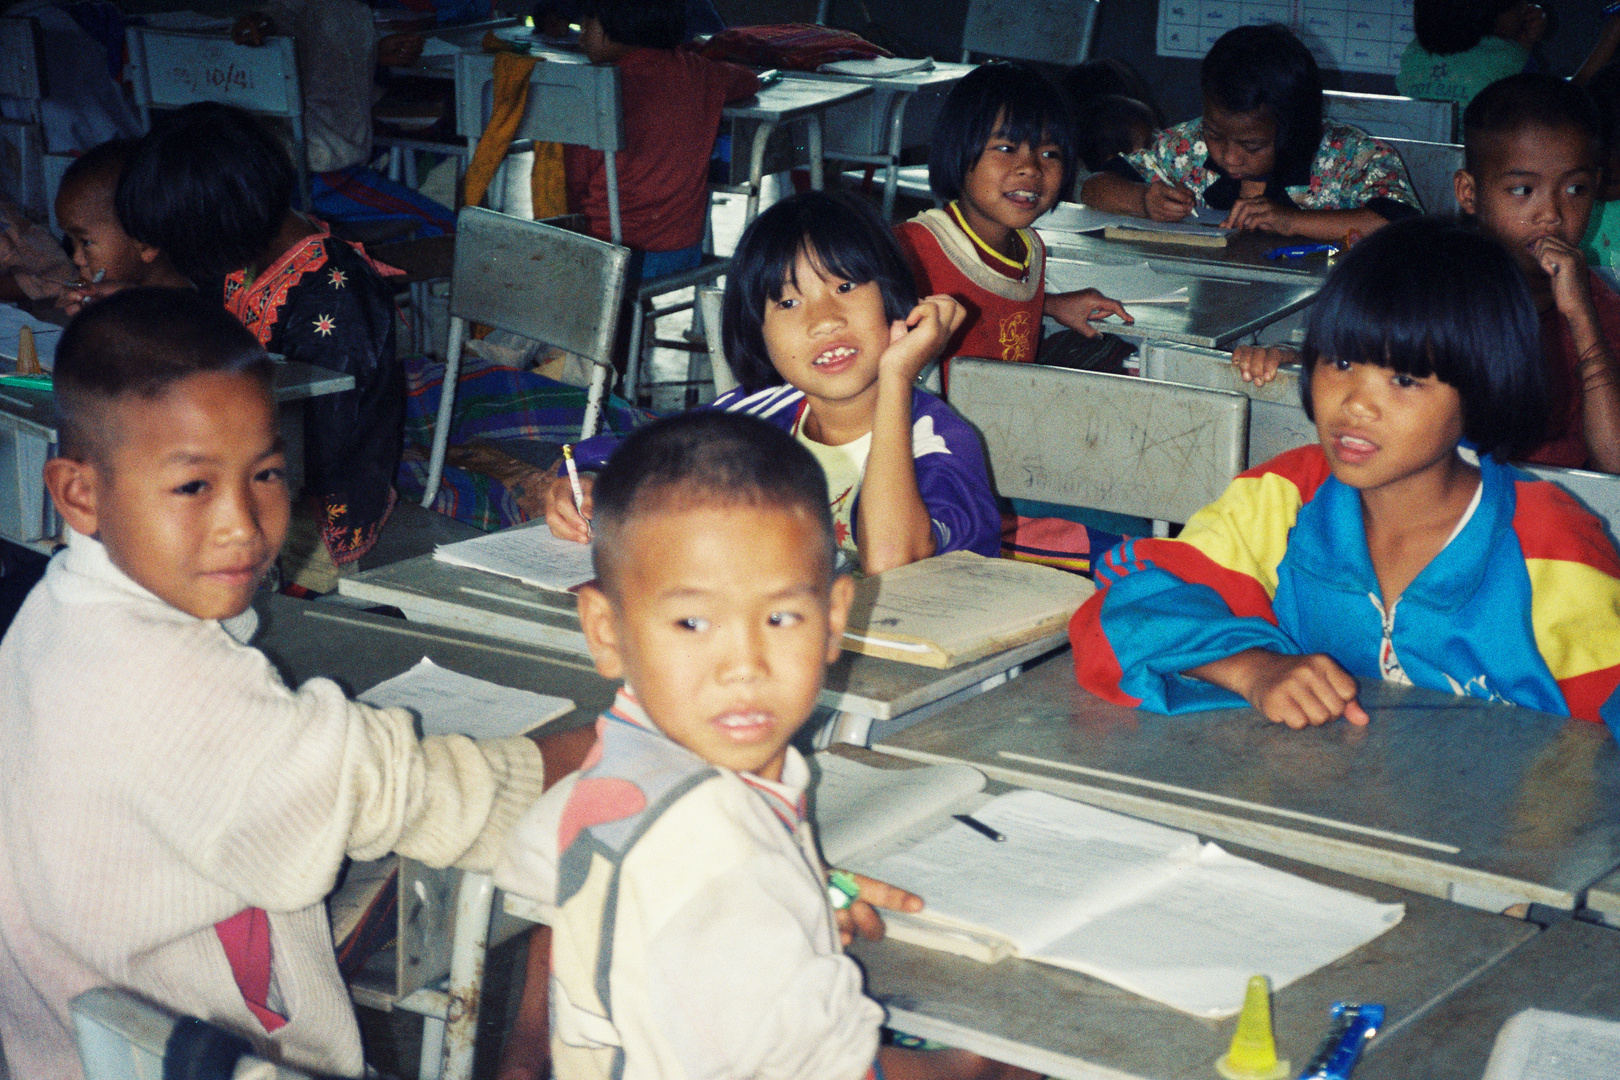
360;656;573;738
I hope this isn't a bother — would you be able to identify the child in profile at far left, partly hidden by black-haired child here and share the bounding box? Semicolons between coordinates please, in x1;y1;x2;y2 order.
57;139;190;314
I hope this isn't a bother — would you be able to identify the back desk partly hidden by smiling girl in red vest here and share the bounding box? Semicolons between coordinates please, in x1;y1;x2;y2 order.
799;60;977;222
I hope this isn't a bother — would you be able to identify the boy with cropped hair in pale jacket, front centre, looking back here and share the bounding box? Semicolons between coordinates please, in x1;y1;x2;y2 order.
496;411;1036;1080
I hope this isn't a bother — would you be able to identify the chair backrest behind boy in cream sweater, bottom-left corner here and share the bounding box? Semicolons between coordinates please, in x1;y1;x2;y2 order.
70;986;309;1080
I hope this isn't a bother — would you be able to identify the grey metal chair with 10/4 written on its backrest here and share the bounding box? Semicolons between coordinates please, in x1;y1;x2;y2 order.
125;26;309;209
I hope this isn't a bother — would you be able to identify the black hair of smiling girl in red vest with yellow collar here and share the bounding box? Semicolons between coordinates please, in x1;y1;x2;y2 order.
928;60;1076;201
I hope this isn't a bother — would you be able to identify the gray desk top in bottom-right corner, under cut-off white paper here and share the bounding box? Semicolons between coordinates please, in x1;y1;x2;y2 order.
1356;921;1620;1080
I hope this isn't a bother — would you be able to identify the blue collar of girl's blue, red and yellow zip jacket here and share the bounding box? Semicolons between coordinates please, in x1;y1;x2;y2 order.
1288;457;1516;610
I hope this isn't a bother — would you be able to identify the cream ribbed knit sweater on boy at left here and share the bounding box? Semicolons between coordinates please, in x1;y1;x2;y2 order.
0;534;541;1080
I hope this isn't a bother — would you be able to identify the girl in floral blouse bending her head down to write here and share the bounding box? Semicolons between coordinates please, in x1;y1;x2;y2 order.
1081;24;1419;241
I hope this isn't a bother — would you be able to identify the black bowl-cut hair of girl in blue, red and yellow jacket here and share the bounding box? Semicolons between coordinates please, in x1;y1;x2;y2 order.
1299;217;1549;460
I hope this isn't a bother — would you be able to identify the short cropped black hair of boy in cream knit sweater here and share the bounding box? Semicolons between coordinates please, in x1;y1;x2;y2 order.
52;287;274;465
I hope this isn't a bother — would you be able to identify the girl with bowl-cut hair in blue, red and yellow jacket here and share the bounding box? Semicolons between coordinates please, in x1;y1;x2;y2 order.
1069;221;1620;730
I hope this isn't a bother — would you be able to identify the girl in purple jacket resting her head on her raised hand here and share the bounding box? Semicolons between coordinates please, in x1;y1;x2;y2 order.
546;191;1001;573
